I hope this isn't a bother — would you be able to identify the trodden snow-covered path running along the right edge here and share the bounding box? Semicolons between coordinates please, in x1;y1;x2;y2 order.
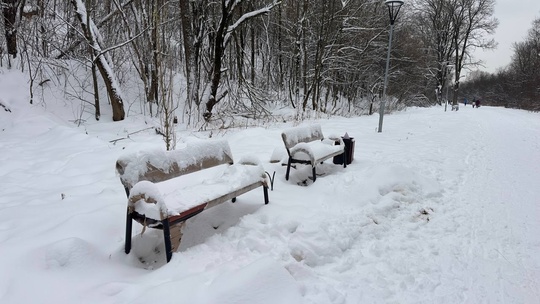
446;107;540;303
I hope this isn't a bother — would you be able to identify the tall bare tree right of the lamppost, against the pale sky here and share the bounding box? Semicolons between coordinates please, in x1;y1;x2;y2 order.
413;0;498;105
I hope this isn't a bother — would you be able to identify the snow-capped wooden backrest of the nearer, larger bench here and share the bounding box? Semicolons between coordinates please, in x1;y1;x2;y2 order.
116;140;233;194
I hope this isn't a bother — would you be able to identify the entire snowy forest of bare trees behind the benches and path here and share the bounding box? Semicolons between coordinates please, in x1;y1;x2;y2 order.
0;0;540;140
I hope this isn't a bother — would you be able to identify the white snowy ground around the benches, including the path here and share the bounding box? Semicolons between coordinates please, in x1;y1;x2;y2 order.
0;70;540;304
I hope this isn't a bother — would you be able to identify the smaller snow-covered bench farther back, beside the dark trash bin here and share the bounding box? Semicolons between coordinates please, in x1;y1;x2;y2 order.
281;125;347;181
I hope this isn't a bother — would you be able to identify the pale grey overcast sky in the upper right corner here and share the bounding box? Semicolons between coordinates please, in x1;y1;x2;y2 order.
474;0;540;73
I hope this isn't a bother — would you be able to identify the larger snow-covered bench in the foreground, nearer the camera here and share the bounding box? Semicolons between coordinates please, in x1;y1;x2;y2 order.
116;140;268;262
